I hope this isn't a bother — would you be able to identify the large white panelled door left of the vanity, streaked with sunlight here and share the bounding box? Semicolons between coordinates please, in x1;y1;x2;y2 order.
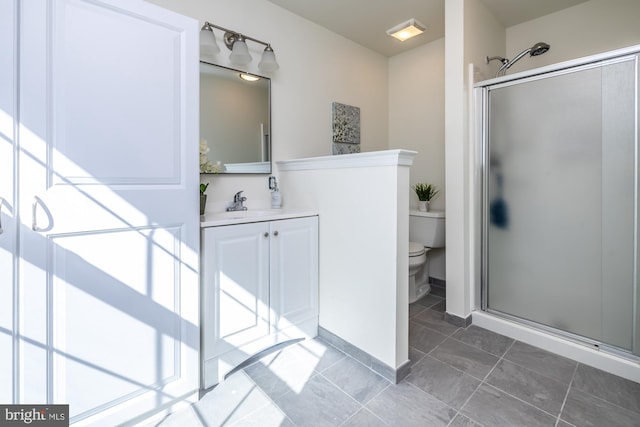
16;0;199;425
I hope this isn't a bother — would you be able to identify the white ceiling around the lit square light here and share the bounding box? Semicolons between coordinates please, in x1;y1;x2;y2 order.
269;0;587;56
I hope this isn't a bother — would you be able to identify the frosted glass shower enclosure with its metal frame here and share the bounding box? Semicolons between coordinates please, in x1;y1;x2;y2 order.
476;48;640;358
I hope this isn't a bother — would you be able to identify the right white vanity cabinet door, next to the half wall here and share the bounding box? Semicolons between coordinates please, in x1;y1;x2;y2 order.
270;217;318;330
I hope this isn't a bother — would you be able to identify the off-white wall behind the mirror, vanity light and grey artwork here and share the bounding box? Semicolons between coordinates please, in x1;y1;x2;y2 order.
149;0;388;211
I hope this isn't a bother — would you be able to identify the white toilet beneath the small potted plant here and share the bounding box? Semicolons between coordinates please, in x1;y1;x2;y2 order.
409;210;445;303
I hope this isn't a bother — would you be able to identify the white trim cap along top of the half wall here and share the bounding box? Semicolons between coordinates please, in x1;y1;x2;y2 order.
276;150;418;172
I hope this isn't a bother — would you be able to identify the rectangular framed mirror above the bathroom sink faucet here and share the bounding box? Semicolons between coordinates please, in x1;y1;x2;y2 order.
200;61;271;174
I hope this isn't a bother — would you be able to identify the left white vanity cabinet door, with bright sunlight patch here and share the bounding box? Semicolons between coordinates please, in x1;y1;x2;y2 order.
202;223;269;365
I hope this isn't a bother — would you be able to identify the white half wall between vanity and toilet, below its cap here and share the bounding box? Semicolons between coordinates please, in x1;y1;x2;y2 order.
282;150;412;369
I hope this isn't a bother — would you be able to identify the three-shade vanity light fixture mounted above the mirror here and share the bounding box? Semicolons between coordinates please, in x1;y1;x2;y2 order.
200;22;280;73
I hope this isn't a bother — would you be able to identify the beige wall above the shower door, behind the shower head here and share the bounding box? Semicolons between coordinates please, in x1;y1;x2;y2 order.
507;0;640;74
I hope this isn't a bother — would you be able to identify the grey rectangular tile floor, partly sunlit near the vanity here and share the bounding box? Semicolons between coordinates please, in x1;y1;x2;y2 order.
160;288;640;427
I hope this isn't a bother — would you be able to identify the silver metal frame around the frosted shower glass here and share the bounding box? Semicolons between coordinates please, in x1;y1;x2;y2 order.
472;46;640;363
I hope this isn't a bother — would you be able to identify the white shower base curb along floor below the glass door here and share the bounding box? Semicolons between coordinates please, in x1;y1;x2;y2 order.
471;311;640;383
